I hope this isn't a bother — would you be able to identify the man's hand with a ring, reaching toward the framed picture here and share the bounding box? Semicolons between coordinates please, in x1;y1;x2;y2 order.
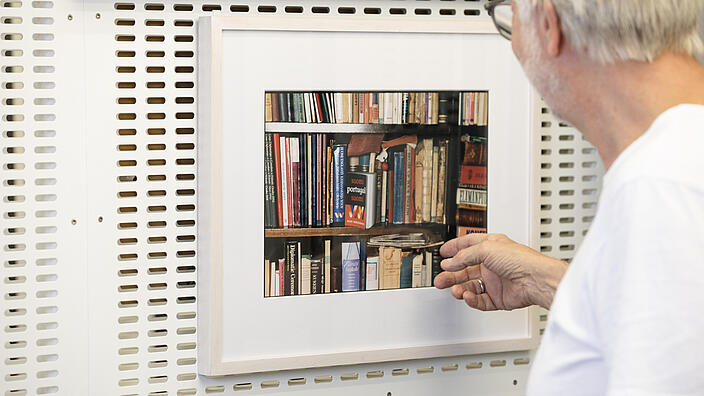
434;234;567;311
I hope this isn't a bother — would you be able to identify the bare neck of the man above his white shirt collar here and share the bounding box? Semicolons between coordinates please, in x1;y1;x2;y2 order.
569;52;704;169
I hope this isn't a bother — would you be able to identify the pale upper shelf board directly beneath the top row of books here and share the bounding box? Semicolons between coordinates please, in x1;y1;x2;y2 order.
264;122;486;135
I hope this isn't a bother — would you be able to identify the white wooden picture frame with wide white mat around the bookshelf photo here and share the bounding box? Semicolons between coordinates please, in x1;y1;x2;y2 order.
197;16;538;376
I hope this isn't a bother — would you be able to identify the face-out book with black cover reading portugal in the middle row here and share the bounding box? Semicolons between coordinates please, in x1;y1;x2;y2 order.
345;172;376;229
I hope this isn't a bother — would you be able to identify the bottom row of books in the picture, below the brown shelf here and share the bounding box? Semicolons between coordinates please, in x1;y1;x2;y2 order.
264;234;442;297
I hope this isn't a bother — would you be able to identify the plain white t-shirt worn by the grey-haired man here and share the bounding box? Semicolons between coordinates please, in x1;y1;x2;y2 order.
527;105;704;396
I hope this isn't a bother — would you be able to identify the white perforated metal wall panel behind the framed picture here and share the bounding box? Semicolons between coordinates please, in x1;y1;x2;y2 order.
0;0;602;396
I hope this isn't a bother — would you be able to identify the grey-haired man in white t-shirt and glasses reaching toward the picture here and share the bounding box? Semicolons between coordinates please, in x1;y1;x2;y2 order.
435;0;704;396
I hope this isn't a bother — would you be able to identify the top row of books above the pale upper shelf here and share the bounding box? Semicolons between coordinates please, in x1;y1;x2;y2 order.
265;91;468;125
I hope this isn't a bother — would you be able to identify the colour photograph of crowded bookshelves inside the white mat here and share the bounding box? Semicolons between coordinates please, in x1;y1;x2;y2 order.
263;91;489;297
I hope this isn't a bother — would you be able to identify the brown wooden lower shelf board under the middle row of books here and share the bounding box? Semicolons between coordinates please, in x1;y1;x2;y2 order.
264;223;447;238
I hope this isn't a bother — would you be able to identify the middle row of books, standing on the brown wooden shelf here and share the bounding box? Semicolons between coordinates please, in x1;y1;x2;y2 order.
264;133;448;228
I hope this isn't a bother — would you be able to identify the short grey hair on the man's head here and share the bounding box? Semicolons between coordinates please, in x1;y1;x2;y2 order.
516;0;704;63
